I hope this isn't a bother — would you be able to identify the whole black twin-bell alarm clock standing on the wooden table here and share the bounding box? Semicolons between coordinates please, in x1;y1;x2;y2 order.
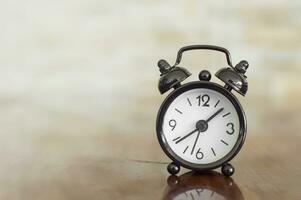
156;45;249;176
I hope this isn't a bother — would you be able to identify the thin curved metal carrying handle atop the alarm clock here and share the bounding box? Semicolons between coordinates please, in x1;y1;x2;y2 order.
174;45;233;68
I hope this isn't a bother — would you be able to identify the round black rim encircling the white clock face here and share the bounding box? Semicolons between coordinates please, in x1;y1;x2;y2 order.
156;81;247;171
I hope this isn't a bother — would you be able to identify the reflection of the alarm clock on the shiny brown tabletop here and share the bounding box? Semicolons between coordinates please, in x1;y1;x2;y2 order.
163;171;244;200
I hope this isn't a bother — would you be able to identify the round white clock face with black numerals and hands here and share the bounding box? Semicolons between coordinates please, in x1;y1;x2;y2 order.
162;88;240;164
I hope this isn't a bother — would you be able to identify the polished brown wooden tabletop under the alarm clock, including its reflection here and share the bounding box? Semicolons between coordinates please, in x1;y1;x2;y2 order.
0;134;301;200
